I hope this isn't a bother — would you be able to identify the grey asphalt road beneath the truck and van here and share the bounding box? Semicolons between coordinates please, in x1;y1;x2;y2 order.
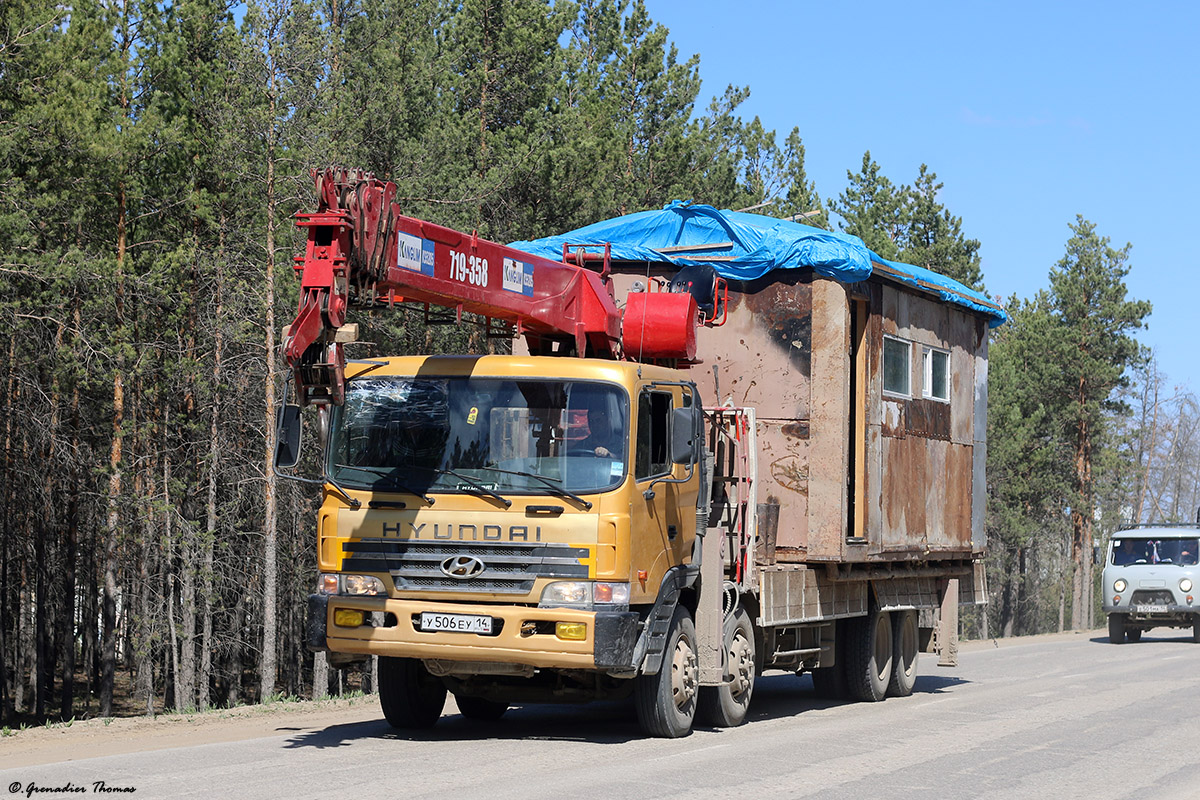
0;631;1200;800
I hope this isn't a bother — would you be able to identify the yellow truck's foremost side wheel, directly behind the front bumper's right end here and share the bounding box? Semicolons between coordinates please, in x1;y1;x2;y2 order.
634;606;700;739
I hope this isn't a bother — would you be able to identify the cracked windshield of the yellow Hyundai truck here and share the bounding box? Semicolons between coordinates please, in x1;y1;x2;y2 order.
328;377;629;495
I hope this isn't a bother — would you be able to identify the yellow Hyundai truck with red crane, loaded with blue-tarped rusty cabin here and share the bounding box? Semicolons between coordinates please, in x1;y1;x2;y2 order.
276;169;1004;738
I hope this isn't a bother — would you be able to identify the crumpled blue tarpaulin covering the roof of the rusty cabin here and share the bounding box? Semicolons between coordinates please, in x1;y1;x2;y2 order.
509;200;1008;327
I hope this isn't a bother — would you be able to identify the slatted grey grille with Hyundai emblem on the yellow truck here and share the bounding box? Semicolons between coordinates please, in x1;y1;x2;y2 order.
342;539;589;595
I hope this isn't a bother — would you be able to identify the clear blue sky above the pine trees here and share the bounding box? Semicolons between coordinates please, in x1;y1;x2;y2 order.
646;0;1200;390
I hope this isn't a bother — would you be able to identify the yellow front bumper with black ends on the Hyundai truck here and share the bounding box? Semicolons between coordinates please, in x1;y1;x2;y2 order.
306;595;641;672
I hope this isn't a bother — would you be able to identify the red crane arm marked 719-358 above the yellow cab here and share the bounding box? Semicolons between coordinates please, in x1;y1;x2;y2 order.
283;168;620;404
